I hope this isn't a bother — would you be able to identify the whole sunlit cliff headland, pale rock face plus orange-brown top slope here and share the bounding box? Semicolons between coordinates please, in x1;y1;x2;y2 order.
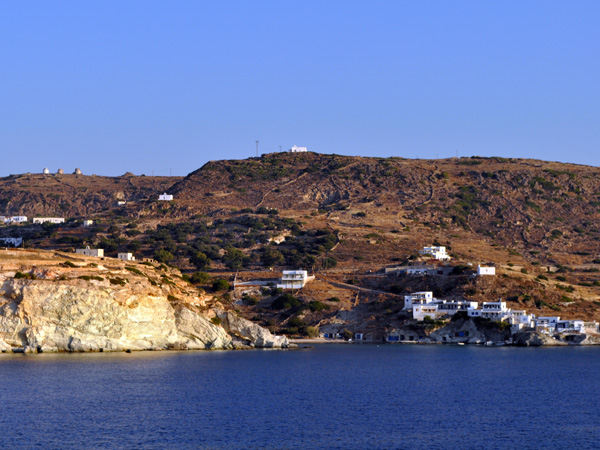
0;251;288;352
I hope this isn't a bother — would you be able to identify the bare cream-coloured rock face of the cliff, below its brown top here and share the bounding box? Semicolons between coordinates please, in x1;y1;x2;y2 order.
0;279;288;352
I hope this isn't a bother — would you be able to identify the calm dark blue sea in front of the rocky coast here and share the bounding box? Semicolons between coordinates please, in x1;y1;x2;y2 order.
0;345;600;449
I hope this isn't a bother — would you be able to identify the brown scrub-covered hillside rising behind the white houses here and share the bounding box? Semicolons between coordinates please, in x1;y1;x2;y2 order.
0;153;600;331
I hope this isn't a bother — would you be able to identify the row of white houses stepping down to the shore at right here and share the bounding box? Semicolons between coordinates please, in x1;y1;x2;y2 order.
404;291;598;333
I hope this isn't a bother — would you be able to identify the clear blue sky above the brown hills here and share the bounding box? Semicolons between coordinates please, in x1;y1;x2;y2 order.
0;0;600;175
